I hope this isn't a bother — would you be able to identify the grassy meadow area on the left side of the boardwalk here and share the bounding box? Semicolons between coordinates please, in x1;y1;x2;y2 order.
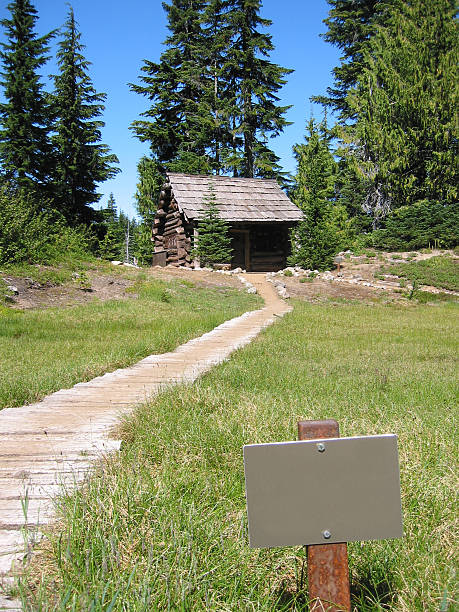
0;270;259;409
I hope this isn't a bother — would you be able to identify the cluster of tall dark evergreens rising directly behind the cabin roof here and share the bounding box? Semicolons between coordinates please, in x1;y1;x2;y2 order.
131;0;290;178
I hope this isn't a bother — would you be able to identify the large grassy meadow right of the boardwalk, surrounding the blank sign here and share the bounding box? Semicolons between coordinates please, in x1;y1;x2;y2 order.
21;302;458;612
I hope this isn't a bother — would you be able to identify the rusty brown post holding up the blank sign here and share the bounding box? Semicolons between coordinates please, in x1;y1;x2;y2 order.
298;419;351;612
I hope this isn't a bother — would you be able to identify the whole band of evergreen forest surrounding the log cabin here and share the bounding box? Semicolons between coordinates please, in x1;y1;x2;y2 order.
0;0;458;269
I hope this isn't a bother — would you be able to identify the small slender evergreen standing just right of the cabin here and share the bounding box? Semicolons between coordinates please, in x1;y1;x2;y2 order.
289;119;345;270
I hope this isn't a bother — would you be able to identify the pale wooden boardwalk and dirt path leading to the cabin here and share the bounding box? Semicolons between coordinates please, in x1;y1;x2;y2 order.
0;274;291;610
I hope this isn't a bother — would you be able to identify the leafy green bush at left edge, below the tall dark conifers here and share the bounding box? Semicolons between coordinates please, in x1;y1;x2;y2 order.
0;188;93;264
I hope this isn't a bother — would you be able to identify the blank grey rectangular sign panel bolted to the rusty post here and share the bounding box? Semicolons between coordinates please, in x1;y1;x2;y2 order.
244;434;403;548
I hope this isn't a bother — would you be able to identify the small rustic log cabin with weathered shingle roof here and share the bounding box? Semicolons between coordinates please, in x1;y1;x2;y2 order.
152;173;302;272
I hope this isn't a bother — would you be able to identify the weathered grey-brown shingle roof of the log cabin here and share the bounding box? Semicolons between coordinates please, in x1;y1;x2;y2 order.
168;173;302;222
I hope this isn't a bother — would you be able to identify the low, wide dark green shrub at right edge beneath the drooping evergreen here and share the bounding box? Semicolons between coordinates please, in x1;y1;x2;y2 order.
368;200;459;251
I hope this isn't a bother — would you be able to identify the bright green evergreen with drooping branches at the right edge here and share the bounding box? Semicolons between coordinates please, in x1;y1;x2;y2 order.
341;0;459;223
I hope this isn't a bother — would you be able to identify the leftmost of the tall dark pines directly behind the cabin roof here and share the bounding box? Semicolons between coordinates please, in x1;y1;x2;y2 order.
131;0;210;173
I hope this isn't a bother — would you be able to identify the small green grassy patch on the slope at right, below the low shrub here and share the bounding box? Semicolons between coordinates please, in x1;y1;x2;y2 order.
381;256;459;291
